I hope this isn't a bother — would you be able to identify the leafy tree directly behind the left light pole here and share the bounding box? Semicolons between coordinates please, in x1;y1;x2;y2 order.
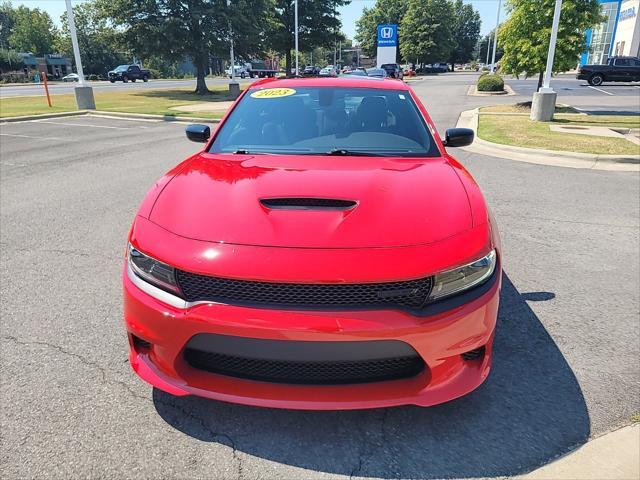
56;3;128;75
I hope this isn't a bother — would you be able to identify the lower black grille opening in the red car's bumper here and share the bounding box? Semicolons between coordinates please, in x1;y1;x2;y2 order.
184;348;424;385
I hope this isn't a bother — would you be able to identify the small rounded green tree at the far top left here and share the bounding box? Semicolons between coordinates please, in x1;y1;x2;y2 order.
2;6;58;55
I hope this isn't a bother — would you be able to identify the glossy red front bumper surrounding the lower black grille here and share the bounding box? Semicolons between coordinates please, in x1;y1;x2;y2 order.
123;262;501;410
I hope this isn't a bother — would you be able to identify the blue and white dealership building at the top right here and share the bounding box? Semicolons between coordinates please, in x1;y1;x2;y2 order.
580;0;640;64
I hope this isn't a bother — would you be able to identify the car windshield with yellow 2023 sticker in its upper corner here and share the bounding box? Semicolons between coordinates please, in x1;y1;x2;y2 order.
209;86;440;157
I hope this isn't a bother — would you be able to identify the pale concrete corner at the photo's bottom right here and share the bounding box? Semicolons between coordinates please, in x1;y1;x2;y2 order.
516;423;640;480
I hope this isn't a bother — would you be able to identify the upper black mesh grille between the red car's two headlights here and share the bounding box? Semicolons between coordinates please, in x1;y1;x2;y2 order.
176;270;432;309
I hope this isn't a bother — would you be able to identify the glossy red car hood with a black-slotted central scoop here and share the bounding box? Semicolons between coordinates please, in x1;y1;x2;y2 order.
149;154;472;248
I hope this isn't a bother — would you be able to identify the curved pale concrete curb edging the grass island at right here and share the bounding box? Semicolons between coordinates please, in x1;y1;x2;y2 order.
457;108;640;172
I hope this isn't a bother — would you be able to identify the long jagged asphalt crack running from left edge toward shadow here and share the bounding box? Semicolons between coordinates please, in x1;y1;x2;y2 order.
1;335;244;480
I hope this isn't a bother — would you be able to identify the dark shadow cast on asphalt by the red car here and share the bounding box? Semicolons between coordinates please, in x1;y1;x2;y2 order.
153;275;590;478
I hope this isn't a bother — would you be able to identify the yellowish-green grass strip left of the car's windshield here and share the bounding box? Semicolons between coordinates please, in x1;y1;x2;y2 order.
0;86;240;118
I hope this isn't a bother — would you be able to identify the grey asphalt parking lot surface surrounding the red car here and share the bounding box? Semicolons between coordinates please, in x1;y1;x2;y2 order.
0;74;640;479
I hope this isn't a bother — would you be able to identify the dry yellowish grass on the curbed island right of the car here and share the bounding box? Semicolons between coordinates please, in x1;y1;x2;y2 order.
478;114;640;155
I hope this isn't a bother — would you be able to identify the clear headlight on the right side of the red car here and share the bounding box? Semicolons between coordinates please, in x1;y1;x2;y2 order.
429;250;496;301
